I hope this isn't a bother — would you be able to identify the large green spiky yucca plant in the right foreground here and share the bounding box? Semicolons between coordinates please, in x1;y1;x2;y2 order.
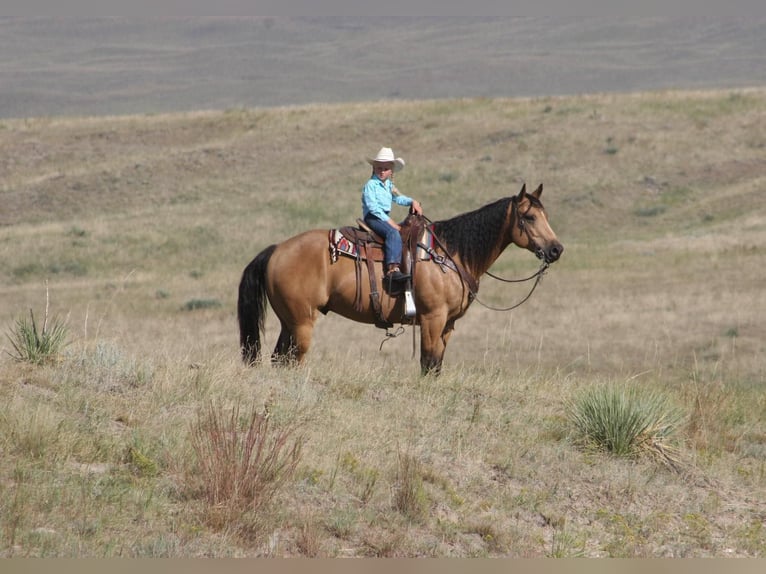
569;385;684;467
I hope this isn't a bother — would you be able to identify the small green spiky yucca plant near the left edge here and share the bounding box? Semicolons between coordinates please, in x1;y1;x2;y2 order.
7;309;69;365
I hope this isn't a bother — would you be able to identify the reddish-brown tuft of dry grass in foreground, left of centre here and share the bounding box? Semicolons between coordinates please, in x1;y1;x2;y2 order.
187;404;303;527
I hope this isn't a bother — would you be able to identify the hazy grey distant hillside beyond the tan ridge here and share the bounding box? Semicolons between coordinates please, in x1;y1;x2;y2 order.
0;14;766;118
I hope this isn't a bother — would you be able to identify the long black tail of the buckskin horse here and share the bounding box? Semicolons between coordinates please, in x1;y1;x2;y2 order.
237;245;277;365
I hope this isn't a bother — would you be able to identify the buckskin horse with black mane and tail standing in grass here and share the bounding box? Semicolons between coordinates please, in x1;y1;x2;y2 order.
237;184;564;374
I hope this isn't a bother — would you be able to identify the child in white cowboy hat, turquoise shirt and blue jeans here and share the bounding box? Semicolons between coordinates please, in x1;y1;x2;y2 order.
362;147;423;281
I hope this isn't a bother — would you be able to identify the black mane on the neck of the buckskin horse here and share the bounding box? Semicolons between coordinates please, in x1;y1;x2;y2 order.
433;197;516;270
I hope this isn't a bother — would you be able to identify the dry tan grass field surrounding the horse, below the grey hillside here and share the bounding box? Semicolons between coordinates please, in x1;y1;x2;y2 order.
0;89;766;557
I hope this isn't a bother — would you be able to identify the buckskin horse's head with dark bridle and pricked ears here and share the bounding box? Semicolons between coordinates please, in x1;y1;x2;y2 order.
511;184;564;263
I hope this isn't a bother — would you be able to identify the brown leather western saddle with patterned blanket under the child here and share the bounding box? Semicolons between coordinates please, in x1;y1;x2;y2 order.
329;214;431;329
